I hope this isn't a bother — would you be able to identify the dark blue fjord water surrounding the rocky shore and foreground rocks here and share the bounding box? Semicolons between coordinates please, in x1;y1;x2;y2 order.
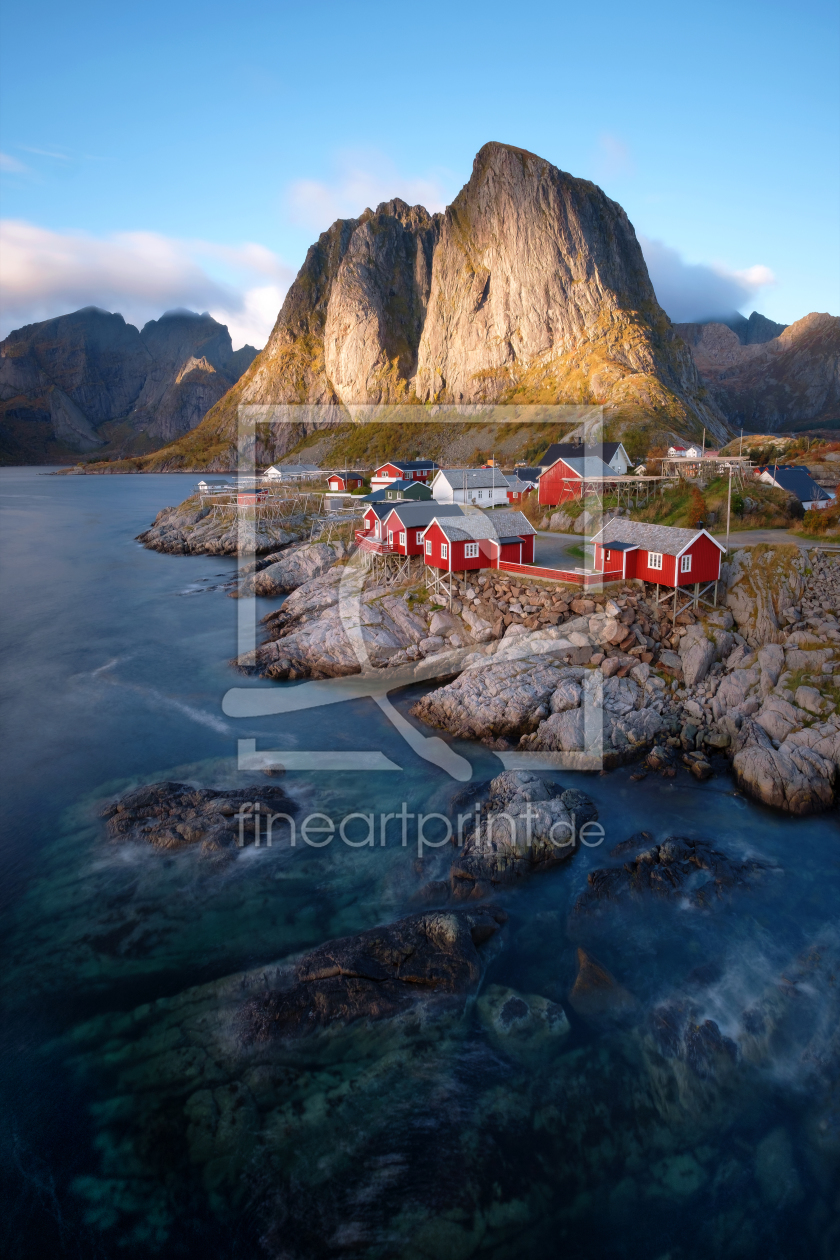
0;469;840;1260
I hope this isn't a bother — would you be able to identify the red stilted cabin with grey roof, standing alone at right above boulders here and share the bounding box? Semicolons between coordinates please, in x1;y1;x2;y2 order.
592;517;725;606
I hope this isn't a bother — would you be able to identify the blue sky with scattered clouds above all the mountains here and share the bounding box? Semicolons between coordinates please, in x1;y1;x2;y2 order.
0;0;840;348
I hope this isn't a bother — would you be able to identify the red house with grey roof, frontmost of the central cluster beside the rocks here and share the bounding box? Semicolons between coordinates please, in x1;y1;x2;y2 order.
423;512;536;573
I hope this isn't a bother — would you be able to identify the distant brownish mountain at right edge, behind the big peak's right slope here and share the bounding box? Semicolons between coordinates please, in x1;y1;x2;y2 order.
675;311;840;433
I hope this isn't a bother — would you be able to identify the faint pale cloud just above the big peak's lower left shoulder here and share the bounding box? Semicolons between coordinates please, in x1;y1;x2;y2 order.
287;151;448;232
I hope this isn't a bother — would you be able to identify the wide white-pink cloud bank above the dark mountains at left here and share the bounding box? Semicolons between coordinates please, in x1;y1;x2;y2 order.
0;219;292;347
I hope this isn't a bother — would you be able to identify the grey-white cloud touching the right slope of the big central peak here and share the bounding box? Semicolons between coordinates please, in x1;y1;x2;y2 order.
639;236;776;324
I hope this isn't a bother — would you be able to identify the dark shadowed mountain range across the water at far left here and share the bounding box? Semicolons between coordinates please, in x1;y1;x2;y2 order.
0;306;257;464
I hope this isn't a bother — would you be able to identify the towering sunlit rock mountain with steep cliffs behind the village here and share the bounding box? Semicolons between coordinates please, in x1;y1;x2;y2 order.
137;144;728;466
